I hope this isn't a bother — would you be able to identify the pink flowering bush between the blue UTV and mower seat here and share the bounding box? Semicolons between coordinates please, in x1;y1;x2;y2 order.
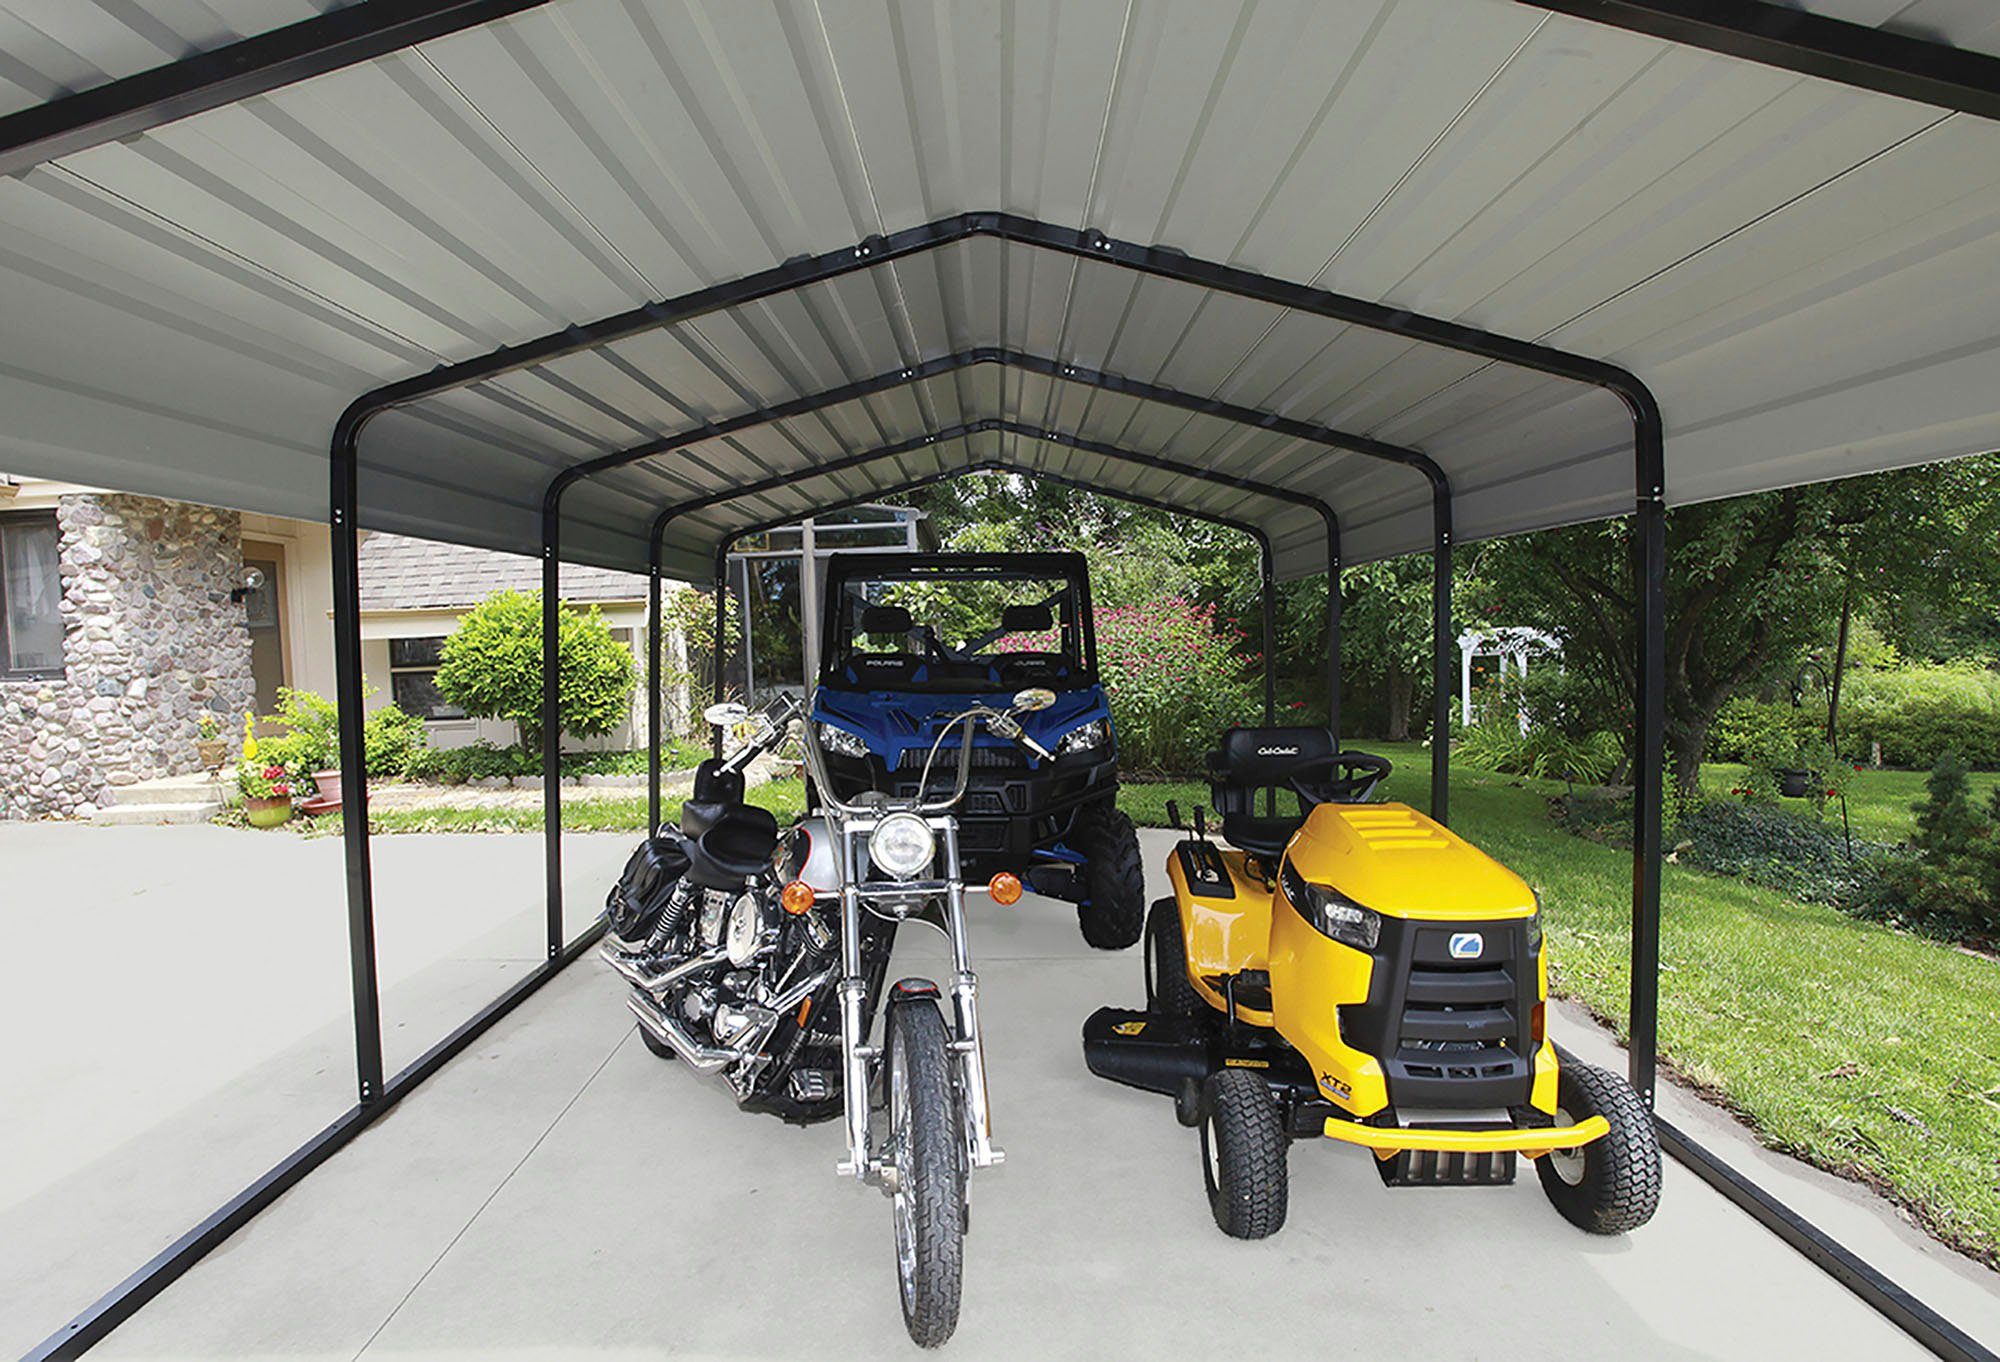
1092;598;1262;776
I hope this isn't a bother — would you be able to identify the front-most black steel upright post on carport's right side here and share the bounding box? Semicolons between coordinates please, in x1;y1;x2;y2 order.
1620;396;1666;1106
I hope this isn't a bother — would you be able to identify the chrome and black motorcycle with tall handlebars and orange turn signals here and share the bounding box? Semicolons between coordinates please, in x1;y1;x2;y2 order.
600;690;1054;1348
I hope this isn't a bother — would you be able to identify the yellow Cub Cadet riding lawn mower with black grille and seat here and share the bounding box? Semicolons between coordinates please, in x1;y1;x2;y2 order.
1084;728;1660;1238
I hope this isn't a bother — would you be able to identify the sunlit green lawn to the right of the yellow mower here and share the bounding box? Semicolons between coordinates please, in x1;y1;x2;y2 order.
1122;744;2000;1266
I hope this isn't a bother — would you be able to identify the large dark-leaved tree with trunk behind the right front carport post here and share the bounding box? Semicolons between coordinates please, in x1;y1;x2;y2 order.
1478;456;2000;796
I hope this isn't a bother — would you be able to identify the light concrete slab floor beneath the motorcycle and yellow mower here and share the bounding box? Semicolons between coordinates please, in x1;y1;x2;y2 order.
58;834;2000;1360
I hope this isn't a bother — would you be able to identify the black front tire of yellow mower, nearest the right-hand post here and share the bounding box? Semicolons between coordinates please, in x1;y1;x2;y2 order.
1534;1048;1660;1234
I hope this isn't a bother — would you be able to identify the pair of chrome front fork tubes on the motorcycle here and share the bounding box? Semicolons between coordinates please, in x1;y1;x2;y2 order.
836;826;1006;1182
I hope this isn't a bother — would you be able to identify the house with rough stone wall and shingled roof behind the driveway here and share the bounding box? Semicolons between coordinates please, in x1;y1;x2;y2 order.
0;474;684;818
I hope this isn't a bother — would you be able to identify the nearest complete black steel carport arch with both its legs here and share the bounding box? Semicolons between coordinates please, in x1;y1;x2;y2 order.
330;212;1666;1104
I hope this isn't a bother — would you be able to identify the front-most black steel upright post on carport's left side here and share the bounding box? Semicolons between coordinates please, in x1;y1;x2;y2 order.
328;408;382;1106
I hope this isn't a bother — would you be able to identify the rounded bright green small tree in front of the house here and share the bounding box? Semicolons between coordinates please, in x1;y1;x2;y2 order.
438;592;636;750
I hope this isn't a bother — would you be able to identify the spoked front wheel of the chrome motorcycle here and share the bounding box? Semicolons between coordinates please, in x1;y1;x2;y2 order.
884;1000;966;1348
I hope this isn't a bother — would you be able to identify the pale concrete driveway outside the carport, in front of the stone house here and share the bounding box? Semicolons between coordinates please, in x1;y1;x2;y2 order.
0;824;632;1356
